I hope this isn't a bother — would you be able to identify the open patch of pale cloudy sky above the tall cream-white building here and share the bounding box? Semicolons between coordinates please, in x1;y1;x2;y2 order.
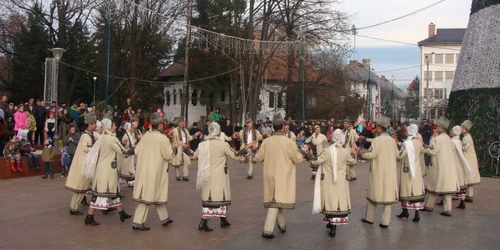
339;0;472;85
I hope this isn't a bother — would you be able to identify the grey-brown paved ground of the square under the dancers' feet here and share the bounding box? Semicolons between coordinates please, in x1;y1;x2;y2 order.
0;159;500;250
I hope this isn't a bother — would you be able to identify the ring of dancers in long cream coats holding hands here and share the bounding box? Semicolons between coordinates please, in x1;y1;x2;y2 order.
65;112;480;239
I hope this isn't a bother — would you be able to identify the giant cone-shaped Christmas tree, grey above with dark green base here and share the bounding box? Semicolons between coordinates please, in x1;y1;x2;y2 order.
447;0;500;174
